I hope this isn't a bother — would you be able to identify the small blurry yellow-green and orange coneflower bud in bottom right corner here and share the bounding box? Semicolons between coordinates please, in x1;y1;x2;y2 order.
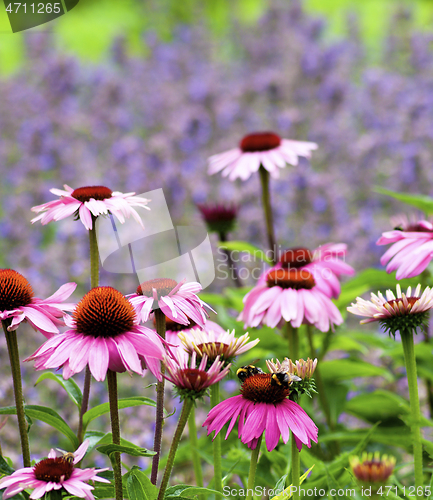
349;452;396;484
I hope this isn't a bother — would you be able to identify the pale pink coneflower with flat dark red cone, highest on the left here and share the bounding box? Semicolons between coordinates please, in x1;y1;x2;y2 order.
31;184;150;230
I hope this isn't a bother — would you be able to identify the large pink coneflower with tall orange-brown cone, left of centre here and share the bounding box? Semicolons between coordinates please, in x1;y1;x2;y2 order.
25;286;165;381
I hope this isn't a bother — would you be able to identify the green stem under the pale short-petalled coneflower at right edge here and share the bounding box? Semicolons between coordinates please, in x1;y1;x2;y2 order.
400;330;423;498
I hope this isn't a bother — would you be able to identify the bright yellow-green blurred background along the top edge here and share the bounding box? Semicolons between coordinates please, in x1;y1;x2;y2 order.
0;0;433;75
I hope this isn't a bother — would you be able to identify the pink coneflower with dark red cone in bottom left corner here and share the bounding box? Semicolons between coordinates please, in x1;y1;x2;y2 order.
0;439;110;500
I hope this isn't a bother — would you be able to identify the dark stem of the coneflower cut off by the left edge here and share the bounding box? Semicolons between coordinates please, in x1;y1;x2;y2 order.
2;319;31;467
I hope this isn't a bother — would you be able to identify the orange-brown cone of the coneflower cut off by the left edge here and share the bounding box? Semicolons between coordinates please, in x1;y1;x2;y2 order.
0;269;33;311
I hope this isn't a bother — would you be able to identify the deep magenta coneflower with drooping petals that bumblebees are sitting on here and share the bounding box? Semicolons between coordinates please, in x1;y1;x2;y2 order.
203;373;318;451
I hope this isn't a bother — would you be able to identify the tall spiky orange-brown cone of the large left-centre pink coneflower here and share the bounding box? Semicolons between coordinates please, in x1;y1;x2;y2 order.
73;286;136;338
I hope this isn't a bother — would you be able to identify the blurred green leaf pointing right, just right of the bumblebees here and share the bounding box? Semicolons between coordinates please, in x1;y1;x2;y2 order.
320;359;392;381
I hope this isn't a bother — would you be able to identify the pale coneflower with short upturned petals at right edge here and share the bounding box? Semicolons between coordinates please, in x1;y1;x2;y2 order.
347;285;433;335
